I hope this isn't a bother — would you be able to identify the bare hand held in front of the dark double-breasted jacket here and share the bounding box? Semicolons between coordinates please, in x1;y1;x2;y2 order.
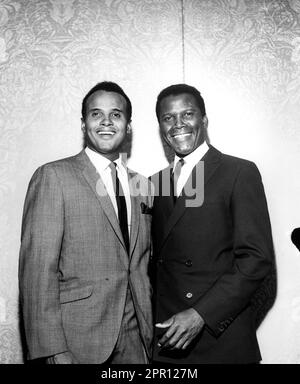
155;308;205;349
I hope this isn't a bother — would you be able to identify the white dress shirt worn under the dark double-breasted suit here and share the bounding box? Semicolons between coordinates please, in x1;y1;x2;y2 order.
173;141;209;196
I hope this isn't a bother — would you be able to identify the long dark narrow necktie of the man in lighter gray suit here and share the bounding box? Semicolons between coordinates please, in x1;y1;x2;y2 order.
109;163;129;253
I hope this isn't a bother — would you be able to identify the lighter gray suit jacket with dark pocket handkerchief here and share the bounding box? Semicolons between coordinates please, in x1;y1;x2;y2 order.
19;151;152;364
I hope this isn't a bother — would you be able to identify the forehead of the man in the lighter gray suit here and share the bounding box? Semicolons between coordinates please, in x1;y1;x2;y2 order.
86;91;126;111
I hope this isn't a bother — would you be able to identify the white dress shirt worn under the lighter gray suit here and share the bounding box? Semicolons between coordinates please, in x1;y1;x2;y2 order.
85;147;131;234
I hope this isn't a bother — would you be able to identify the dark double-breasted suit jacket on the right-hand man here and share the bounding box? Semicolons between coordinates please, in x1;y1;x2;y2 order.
152;146;274;364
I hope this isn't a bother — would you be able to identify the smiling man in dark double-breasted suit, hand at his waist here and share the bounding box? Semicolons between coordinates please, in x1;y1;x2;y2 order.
152;84;273;364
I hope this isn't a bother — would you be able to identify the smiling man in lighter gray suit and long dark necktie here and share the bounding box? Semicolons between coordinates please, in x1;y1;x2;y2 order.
19;82;152;364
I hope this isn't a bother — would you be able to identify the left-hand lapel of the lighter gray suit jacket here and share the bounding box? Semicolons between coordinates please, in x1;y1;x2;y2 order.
75;150;128;265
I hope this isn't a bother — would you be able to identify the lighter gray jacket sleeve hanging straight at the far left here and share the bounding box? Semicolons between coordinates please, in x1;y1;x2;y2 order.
19;165;68;359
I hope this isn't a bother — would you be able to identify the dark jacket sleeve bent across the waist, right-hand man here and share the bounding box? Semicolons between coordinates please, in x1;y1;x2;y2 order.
194;163;274;336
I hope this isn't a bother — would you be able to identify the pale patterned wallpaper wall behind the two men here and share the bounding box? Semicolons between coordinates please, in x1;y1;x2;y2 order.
0;0;300;363
